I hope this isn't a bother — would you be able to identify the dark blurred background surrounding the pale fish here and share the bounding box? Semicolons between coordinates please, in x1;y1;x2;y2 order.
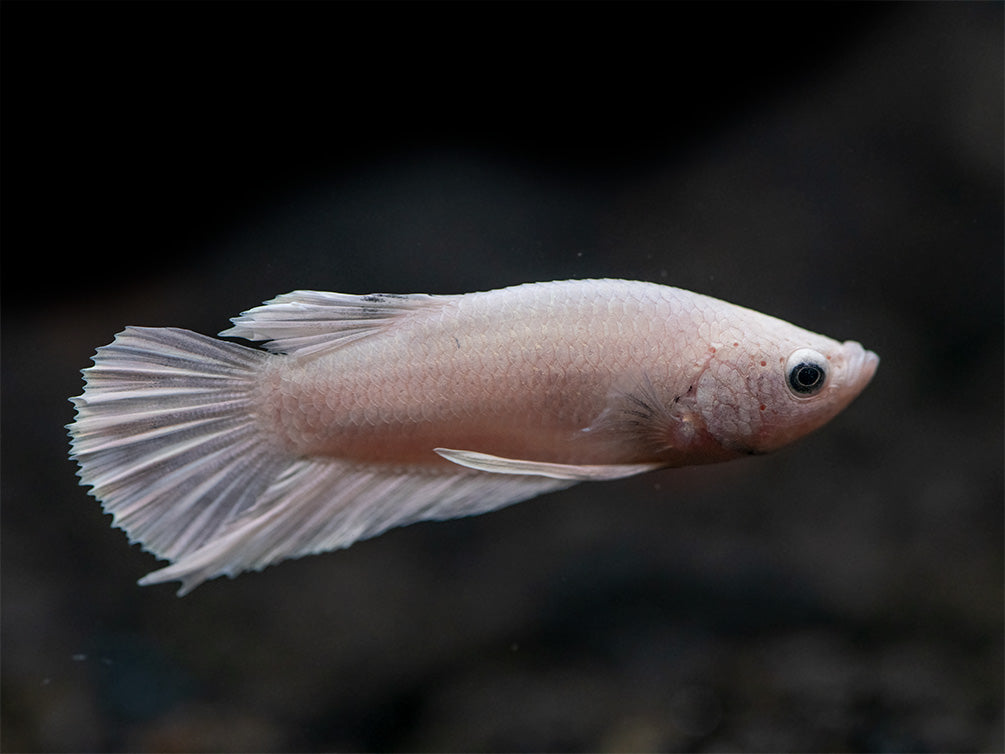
0;1;1003;752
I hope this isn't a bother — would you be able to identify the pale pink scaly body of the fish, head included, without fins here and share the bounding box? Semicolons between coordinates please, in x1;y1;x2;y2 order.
260;280;871;465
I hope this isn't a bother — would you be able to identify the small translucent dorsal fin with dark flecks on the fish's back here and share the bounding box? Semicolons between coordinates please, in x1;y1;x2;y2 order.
220;291;459;356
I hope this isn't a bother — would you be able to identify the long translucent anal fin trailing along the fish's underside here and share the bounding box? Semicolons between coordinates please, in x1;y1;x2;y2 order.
140;459;575;595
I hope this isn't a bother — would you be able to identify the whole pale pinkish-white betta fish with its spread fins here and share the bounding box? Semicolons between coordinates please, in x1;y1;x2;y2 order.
68;279;879;594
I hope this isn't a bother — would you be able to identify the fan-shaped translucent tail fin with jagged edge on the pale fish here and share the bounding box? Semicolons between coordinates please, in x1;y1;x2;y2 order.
67;327;292;586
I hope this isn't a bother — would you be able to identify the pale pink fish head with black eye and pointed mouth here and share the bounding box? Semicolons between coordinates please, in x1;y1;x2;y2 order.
694;318;879;453
